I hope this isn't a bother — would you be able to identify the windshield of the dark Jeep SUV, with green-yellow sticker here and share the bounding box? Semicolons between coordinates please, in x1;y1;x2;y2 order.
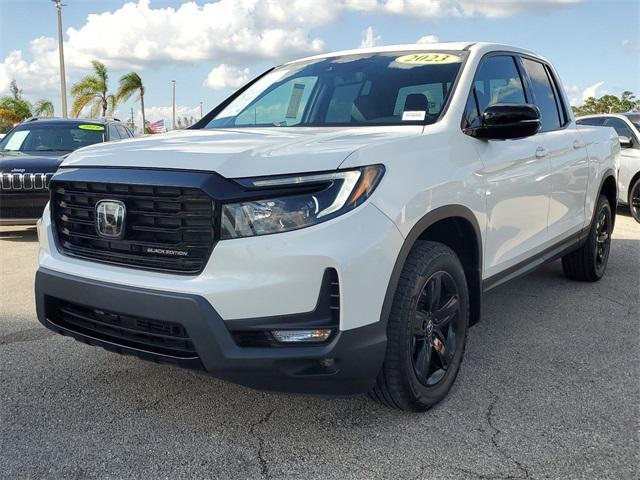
0;124;104;152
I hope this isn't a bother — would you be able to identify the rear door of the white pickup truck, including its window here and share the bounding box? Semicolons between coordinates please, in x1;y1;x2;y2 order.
521;56;590;238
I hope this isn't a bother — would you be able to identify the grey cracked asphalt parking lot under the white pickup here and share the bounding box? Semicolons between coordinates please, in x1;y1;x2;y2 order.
0;214;640;479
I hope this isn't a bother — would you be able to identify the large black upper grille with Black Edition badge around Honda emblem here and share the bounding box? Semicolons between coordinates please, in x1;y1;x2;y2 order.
51;180;214;273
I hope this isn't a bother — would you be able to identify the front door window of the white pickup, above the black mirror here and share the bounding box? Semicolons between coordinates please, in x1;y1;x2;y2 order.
463;55;527;128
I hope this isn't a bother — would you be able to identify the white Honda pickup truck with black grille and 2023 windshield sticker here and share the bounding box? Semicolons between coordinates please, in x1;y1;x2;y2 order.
36;43;620;411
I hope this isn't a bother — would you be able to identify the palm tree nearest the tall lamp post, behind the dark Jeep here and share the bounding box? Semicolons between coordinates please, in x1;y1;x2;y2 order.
71;60;118;117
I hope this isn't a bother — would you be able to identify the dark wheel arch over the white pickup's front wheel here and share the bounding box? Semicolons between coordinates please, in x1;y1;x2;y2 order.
380;205;482;325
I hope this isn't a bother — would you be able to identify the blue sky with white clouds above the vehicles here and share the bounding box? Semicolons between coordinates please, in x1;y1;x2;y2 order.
0;0;640;129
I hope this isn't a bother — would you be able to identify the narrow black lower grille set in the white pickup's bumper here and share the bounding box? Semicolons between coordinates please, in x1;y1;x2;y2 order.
46;298;198;359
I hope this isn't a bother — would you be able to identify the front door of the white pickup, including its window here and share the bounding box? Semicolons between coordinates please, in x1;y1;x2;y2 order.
463;54;551;277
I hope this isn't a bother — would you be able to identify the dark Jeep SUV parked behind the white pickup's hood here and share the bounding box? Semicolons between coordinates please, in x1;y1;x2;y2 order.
0;118;133;225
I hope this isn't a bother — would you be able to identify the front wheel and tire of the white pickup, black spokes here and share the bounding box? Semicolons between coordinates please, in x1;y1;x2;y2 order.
369;241;469;412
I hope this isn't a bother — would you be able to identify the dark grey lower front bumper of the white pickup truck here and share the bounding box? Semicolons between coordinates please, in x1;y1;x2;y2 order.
36;268;386;395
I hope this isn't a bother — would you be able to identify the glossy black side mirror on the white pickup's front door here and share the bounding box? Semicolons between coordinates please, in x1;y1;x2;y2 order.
467;103;541;140
